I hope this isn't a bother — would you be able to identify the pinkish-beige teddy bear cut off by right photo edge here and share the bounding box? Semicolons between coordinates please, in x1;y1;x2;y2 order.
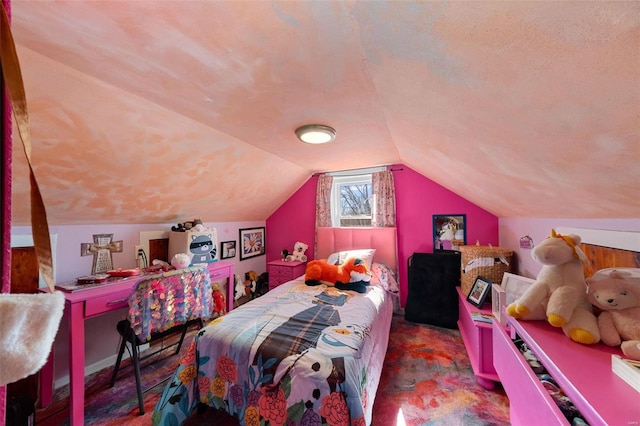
587;268;640;361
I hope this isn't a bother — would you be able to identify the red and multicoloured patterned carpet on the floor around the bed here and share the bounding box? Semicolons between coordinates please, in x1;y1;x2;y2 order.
36;315;509;426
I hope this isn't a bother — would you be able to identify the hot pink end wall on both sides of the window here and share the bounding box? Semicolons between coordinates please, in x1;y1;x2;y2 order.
266;165;498;306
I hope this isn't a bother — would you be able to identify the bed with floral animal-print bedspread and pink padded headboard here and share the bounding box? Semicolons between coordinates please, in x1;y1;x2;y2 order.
152;228;397;425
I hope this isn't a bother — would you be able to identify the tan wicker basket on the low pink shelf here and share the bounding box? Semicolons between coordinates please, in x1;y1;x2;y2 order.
458;245;513;295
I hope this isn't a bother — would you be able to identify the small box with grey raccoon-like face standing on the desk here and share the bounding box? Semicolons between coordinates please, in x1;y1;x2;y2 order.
169;228;220;265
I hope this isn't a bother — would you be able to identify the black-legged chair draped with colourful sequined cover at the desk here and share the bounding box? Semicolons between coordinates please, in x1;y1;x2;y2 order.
110;267;213;415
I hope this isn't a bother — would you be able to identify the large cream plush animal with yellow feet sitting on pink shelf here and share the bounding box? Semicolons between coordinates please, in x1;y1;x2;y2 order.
506;229;600;345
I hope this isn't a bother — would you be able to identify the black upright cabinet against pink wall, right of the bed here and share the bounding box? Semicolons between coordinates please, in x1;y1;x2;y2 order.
405;250;461;328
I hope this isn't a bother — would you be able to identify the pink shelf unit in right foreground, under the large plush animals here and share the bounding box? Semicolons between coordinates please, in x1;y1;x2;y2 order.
493;318;640;426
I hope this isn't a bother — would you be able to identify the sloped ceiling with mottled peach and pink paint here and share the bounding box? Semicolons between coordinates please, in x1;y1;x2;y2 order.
6;0;640;225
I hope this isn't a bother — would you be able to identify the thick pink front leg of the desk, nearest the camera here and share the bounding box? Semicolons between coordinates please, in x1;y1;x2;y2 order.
69;302;84;426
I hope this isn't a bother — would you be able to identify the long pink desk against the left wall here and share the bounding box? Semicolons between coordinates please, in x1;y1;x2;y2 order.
40;262;234;425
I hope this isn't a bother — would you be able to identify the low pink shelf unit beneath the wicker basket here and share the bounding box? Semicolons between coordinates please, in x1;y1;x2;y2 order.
457;287;500;389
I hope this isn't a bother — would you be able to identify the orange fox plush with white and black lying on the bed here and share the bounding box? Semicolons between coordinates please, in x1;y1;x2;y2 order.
304;257;371;293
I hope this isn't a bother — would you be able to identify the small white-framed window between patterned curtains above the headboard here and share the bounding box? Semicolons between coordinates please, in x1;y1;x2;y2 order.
331;174;373;227
